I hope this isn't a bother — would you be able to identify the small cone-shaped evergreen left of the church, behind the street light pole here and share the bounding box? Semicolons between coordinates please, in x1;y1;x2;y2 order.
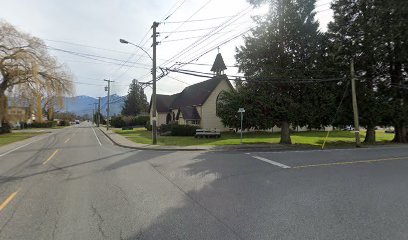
122;79;149;116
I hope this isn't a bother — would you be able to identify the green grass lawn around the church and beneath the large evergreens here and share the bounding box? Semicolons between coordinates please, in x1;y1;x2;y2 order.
114;128;394;147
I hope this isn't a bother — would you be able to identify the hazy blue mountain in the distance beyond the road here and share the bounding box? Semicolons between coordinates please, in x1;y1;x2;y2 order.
60;94;125;116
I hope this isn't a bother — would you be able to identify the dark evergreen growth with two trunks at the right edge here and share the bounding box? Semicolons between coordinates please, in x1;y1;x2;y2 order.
329;0;408;142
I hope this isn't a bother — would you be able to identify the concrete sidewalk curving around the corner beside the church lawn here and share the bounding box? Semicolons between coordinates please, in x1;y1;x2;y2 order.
99;127;298;151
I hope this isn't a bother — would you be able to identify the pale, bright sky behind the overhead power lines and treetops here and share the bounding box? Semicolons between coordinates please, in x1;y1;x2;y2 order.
0;0;332;97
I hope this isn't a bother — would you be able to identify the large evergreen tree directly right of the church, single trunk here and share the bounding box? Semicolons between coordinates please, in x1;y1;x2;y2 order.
236;0;336;144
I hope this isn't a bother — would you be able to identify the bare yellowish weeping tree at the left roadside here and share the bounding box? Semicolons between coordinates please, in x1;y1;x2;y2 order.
0;21;74;126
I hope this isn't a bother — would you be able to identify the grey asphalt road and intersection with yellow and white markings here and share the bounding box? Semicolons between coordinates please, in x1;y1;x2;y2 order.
0;124;408;239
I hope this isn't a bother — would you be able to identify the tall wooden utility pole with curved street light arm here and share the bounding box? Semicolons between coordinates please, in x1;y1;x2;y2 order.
119;33;159;145
